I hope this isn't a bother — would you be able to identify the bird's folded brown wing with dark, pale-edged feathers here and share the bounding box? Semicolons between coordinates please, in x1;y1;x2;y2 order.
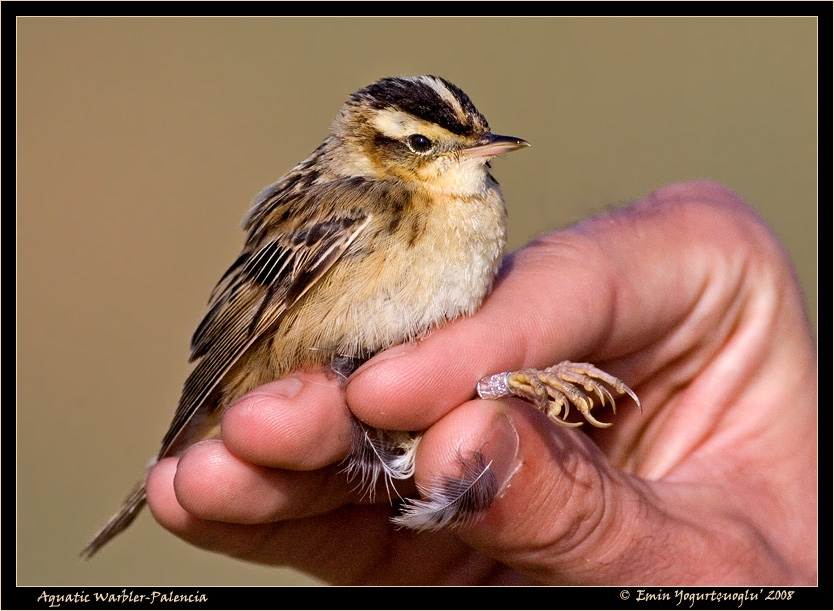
159;184;372;458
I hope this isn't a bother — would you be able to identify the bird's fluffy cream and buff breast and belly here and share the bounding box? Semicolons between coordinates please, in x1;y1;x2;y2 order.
274;185;506;362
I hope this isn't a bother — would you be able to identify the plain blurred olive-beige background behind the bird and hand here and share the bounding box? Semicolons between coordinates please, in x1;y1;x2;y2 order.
17;18;817;586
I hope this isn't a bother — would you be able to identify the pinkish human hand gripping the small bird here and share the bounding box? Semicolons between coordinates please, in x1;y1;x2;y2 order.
143;183;817;585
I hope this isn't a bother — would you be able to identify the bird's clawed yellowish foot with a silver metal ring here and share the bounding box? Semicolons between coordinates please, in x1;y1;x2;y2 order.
478;361;642;428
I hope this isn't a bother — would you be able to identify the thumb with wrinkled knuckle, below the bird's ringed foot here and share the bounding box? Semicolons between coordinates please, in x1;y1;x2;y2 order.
404;399;674;584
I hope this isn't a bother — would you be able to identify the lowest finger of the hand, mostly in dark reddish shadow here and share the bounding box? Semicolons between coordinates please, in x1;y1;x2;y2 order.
147;456;504;585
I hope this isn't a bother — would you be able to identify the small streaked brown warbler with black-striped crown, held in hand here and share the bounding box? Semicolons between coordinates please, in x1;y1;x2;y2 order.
81;76;639;557
